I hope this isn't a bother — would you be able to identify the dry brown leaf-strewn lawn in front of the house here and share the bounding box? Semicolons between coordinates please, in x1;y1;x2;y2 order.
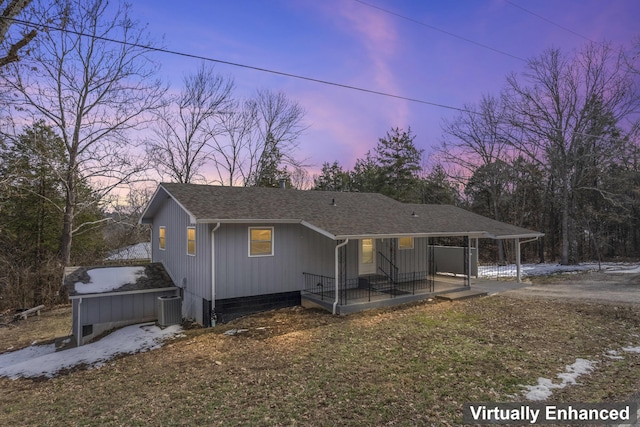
0;290;640;426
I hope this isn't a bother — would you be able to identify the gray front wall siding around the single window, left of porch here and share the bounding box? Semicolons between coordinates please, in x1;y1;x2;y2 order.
214;223;335;300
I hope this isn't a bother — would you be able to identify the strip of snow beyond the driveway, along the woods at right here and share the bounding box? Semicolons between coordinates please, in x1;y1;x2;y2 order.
478;262;640;278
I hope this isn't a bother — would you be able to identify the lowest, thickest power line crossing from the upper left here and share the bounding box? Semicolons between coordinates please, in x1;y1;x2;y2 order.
0;16;471;113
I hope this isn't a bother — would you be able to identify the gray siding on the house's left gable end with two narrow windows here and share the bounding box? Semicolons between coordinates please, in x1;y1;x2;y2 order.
152;198;212;322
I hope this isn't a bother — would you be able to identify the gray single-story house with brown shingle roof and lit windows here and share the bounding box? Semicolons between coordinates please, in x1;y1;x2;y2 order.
140;183;543;325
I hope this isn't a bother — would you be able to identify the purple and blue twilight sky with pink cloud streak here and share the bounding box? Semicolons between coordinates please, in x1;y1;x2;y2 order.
133;0;640;177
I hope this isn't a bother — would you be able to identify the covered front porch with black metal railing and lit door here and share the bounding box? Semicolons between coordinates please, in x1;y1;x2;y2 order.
301;234;540;314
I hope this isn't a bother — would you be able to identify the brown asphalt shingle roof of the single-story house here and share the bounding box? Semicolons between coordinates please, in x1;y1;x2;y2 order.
141;183;542;238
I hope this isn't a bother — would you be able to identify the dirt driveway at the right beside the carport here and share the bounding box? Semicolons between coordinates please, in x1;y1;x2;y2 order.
501;272;640;305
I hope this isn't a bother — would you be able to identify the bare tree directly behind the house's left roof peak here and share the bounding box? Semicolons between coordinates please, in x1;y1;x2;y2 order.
147;64;233;183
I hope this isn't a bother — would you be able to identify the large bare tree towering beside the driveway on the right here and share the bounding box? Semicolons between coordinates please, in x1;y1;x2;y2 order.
503;44;640;264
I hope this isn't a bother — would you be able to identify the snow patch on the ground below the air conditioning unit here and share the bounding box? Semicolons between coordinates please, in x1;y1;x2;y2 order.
0;323;182;379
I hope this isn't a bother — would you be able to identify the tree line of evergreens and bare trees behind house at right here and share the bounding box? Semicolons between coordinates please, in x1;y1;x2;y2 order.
314;44;640;264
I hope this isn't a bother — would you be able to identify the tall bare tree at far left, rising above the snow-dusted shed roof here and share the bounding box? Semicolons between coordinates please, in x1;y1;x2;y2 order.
4;0;163;265
